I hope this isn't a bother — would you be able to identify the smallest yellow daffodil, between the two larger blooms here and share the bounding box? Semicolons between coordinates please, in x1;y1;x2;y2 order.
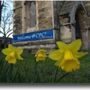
35;49;47;61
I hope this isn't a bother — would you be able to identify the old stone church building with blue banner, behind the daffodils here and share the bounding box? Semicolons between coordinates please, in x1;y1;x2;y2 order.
13;0;90;50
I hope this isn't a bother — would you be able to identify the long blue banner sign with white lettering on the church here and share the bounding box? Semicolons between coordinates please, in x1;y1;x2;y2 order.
13;29;54;42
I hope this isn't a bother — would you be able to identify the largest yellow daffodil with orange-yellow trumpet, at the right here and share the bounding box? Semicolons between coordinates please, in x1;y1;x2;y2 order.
49;39;87;72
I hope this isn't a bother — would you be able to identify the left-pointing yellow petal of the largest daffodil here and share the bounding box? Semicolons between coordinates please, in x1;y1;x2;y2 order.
49;50;63;61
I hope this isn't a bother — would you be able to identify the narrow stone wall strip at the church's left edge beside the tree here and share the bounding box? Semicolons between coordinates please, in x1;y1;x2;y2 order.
14;1;22;35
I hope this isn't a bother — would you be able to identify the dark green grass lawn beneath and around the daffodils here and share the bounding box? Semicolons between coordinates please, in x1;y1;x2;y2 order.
0;52;90;84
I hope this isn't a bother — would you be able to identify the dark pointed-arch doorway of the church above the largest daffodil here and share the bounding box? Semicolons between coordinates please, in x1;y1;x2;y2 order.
75;6;88;49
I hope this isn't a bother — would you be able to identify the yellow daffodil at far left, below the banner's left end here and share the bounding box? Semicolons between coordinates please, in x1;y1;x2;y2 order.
2;44;23;64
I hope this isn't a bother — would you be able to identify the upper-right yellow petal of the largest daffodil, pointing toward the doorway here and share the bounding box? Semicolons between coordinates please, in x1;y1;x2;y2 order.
68;39;82;52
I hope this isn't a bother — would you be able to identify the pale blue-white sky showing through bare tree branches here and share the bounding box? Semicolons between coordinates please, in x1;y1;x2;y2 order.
0;0;13;37
